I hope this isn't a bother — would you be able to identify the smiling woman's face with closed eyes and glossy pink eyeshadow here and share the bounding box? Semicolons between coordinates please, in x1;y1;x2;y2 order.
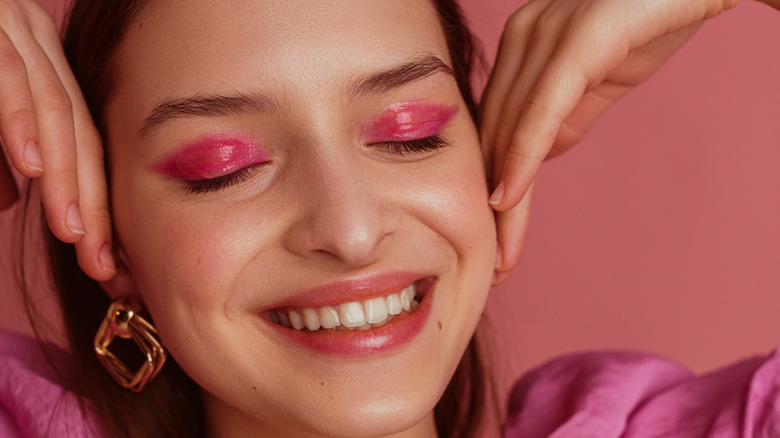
107;0;495;436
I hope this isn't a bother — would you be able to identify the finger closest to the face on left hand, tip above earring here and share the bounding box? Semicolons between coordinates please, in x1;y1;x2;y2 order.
31;17;116;281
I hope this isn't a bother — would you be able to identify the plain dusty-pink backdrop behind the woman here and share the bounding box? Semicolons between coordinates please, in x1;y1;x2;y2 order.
0;0;780;402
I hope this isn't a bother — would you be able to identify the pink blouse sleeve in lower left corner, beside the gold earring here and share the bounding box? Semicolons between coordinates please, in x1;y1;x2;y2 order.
0;329;105;437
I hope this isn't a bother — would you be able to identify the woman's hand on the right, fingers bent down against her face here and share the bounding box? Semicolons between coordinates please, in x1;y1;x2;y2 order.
480;0;752;284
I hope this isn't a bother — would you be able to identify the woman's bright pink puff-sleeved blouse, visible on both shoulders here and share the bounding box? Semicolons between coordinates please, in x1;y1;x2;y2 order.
0;329;780;438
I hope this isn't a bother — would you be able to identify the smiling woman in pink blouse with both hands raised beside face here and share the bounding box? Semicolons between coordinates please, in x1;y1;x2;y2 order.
0;0;780;438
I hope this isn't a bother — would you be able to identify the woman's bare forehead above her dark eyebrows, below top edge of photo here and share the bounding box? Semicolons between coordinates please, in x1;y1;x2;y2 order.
112;0;449;104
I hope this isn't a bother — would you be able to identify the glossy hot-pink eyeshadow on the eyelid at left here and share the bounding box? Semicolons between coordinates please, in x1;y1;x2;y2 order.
154;135;269;180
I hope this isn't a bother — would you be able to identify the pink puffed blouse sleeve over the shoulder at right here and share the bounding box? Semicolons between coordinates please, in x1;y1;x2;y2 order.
504;351;780;438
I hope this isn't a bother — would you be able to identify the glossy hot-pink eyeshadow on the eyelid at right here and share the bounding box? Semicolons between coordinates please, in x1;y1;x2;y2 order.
366;102;458;143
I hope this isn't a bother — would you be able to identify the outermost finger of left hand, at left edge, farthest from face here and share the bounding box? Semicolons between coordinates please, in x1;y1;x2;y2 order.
0;28;43;178
